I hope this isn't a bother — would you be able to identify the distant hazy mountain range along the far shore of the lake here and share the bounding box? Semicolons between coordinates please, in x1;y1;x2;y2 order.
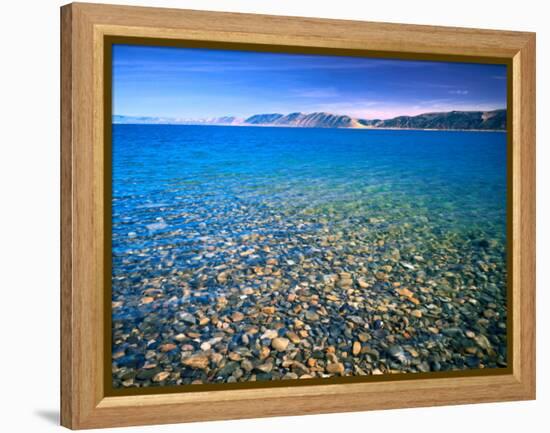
113;109;506;130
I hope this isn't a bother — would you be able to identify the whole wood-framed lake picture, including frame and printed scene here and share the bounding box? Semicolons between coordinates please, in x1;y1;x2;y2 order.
61;4;535;429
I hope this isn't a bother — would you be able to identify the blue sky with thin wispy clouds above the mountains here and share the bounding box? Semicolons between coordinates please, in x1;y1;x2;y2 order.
113;45;506;119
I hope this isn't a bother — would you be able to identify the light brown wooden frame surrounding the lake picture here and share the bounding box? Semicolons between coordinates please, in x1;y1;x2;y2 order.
61;3;535;429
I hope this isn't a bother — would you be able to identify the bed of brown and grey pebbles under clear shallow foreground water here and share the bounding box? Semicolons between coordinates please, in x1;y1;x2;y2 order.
112;202;507;388
